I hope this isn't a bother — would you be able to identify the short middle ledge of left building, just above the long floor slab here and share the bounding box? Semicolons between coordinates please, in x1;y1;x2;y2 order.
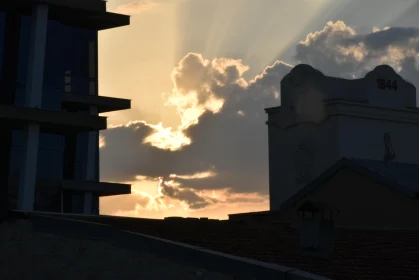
62;93;131;113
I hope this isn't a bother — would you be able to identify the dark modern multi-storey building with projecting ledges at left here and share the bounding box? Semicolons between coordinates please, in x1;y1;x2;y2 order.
0;0;131;214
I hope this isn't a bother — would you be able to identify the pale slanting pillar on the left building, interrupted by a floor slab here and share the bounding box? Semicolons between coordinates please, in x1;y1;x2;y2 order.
18;4;48;211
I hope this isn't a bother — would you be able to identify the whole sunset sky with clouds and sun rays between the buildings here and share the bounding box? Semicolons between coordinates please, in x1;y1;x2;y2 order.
99;0;419;219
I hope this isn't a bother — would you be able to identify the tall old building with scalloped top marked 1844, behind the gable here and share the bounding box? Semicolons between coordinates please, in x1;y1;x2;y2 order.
266;65;419;210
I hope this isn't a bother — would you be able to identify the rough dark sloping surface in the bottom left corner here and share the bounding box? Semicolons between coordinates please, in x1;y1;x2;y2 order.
0;219;236;280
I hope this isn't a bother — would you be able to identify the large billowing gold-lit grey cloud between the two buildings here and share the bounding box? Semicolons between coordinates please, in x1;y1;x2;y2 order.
101;54;291;193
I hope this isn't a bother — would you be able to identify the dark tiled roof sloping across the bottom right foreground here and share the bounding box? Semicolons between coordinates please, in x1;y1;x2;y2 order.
43;213;419;280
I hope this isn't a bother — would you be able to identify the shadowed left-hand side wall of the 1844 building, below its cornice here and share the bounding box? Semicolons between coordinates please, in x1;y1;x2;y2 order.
269;119;340;210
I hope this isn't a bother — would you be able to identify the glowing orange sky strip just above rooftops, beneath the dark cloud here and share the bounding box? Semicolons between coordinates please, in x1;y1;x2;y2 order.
100;176;269;219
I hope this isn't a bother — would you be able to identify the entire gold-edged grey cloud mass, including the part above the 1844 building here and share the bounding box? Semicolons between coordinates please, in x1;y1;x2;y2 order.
101;21;419;209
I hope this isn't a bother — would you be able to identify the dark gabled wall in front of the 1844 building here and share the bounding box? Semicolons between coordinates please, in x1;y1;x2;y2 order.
283;168;419;228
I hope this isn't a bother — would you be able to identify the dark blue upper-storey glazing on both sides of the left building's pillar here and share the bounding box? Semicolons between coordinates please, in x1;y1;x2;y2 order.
16;16;97;110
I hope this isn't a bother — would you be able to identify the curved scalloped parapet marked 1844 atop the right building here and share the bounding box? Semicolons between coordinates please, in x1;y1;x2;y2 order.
281;64;416;109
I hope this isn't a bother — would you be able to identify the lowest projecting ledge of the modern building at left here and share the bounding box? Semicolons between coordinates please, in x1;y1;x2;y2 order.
61;180;131;196
